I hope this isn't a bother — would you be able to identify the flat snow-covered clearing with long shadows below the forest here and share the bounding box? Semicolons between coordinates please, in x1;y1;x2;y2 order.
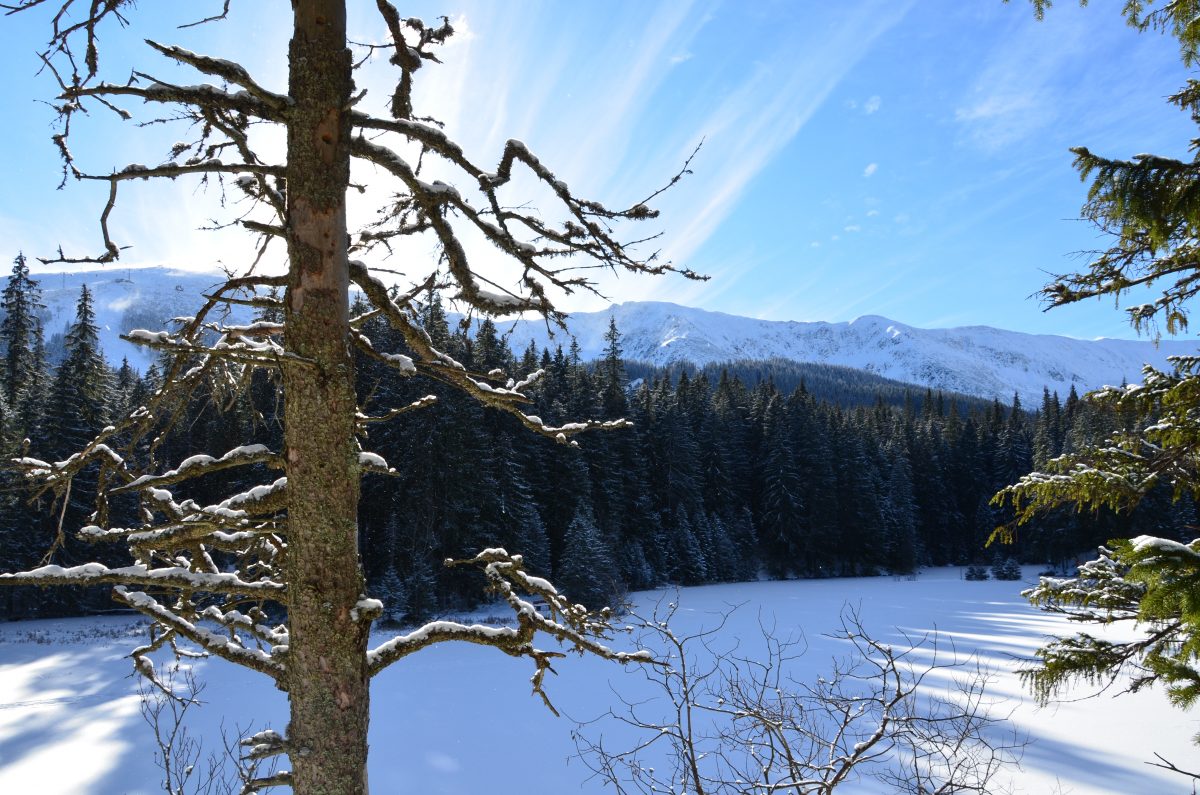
0;568;1198;795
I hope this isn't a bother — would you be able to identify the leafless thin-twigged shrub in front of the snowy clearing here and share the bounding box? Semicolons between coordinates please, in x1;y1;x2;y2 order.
575;603;1024;795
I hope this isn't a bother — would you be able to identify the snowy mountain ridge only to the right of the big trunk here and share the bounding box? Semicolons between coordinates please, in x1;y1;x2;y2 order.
500;301;1196;407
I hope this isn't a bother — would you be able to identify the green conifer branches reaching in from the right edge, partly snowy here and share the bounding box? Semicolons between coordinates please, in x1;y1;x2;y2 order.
996;0;1200;734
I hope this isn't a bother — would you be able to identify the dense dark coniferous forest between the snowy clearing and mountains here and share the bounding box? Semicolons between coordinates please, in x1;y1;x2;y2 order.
0;257;1195;621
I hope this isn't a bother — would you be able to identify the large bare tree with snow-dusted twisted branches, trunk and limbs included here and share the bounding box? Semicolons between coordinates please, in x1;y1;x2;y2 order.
0;0;695;795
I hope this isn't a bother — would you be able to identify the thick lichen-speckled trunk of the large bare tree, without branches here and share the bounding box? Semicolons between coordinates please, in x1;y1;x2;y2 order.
283;0;368;795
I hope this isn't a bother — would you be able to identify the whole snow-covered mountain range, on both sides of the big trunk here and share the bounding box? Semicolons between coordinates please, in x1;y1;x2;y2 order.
23;268;1196;407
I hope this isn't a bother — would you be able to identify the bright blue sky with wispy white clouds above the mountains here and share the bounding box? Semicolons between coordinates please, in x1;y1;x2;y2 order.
0;0;1195;337
